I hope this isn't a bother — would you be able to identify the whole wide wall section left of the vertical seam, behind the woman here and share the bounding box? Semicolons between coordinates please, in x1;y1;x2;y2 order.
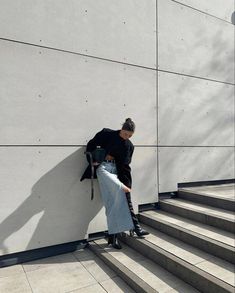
0;0;158;254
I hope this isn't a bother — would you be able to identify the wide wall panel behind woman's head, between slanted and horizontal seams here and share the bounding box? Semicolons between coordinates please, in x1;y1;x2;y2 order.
0;41;157;145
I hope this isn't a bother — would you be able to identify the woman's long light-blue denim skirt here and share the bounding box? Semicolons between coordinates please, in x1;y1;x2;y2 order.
96;162;134;234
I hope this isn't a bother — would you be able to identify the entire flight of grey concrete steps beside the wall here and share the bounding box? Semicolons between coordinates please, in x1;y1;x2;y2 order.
90;185;235;293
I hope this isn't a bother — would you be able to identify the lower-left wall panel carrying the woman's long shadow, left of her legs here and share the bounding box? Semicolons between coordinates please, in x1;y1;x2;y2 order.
0;148;103;254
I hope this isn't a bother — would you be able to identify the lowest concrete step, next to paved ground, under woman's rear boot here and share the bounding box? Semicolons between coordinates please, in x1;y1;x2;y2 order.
89;239;199;293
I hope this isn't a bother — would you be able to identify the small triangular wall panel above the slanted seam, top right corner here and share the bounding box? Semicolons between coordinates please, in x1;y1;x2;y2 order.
177;0;235;22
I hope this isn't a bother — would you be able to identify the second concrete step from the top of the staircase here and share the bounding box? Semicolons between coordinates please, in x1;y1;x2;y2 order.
160;198;235;233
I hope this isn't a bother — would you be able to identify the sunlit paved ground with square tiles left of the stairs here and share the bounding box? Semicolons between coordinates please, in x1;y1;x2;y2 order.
0;249;133;293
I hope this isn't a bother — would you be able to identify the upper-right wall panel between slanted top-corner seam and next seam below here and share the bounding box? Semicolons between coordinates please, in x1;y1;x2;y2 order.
158;0;234;83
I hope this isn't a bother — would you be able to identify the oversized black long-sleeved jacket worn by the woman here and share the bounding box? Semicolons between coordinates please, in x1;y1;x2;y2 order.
81;128;134;188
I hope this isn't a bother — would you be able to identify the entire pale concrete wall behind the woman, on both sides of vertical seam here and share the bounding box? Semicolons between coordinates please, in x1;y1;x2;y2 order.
0;0;234;255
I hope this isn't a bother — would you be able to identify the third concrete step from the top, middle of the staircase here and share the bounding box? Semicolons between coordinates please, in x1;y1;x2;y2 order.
139;210;235;264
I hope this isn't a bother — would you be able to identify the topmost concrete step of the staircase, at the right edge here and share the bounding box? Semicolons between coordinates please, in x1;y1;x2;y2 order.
177;184;235;211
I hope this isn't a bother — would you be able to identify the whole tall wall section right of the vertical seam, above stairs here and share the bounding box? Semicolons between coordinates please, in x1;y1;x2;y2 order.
157;0;234;192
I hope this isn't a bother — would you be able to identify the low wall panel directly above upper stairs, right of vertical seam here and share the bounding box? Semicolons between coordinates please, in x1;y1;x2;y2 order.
158;147;235;192
